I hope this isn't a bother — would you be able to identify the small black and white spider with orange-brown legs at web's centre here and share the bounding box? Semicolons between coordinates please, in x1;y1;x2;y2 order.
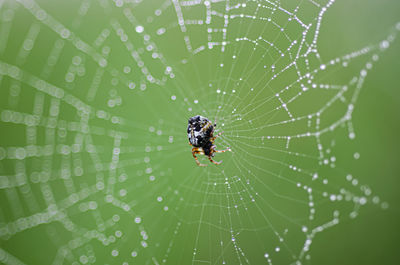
187;115;231;167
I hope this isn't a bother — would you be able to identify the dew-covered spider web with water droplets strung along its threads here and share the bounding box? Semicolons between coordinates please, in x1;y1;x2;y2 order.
0;0;400;264
